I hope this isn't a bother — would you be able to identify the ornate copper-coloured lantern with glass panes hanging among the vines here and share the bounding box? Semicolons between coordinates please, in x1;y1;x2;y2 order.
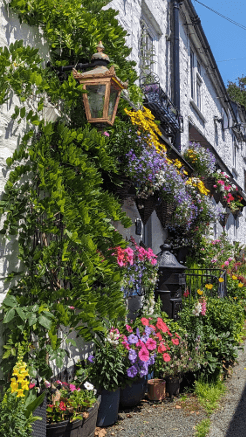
73;41;128;126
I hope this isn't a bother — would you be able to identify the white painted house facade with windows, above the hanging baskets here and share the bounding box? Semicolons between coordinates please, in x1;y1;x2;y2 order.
108;0;246;247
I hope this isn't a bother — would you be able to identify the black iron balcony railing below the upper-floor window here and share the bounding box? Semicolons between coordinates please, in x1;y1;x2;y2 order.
141;83;183;137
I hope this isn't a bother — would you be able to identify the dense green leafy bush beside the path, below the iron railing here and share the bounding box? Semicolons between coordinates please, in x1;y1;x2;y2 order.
179;297;244;378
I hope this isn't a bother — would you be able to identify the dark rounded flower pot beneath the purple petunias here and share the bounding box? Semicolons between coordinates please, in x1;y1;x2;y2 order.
120;377;147;408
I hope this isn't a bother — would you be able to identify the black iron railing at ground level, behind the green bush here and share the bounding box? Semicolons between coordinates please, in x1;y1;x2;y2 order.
185;269;227;297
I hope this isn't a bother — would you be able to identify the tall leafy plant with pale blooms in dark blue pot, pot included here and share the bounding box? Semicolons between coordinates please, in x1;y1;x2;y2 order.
87;327;126;426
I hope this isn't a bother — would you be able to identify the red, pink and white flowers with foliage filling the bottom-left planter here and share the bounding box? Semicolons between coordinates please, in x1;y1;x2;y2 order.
45;380;96;423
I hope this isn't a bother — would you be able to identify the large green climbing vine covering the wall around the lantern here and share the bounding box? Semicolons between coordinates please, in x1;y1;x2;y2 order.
0;0;139;379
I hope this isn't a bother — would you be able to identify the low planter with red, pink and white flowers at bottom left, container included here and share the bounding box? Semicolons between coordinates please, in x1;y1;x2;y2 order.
45;380;100;437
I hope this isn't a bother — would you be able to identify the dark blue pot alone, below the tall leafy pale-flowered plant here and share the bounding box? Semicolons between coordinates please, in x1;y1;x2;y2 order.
97;388;120;427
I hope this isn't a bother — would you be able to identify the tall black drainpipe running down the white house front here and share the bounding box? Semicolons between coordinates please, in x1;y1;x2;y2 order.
172;0;181;152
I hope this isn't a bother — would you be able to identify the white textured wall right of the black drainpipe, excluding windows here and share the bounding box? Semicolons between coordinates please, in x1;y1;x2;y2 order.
180;19;246;244
